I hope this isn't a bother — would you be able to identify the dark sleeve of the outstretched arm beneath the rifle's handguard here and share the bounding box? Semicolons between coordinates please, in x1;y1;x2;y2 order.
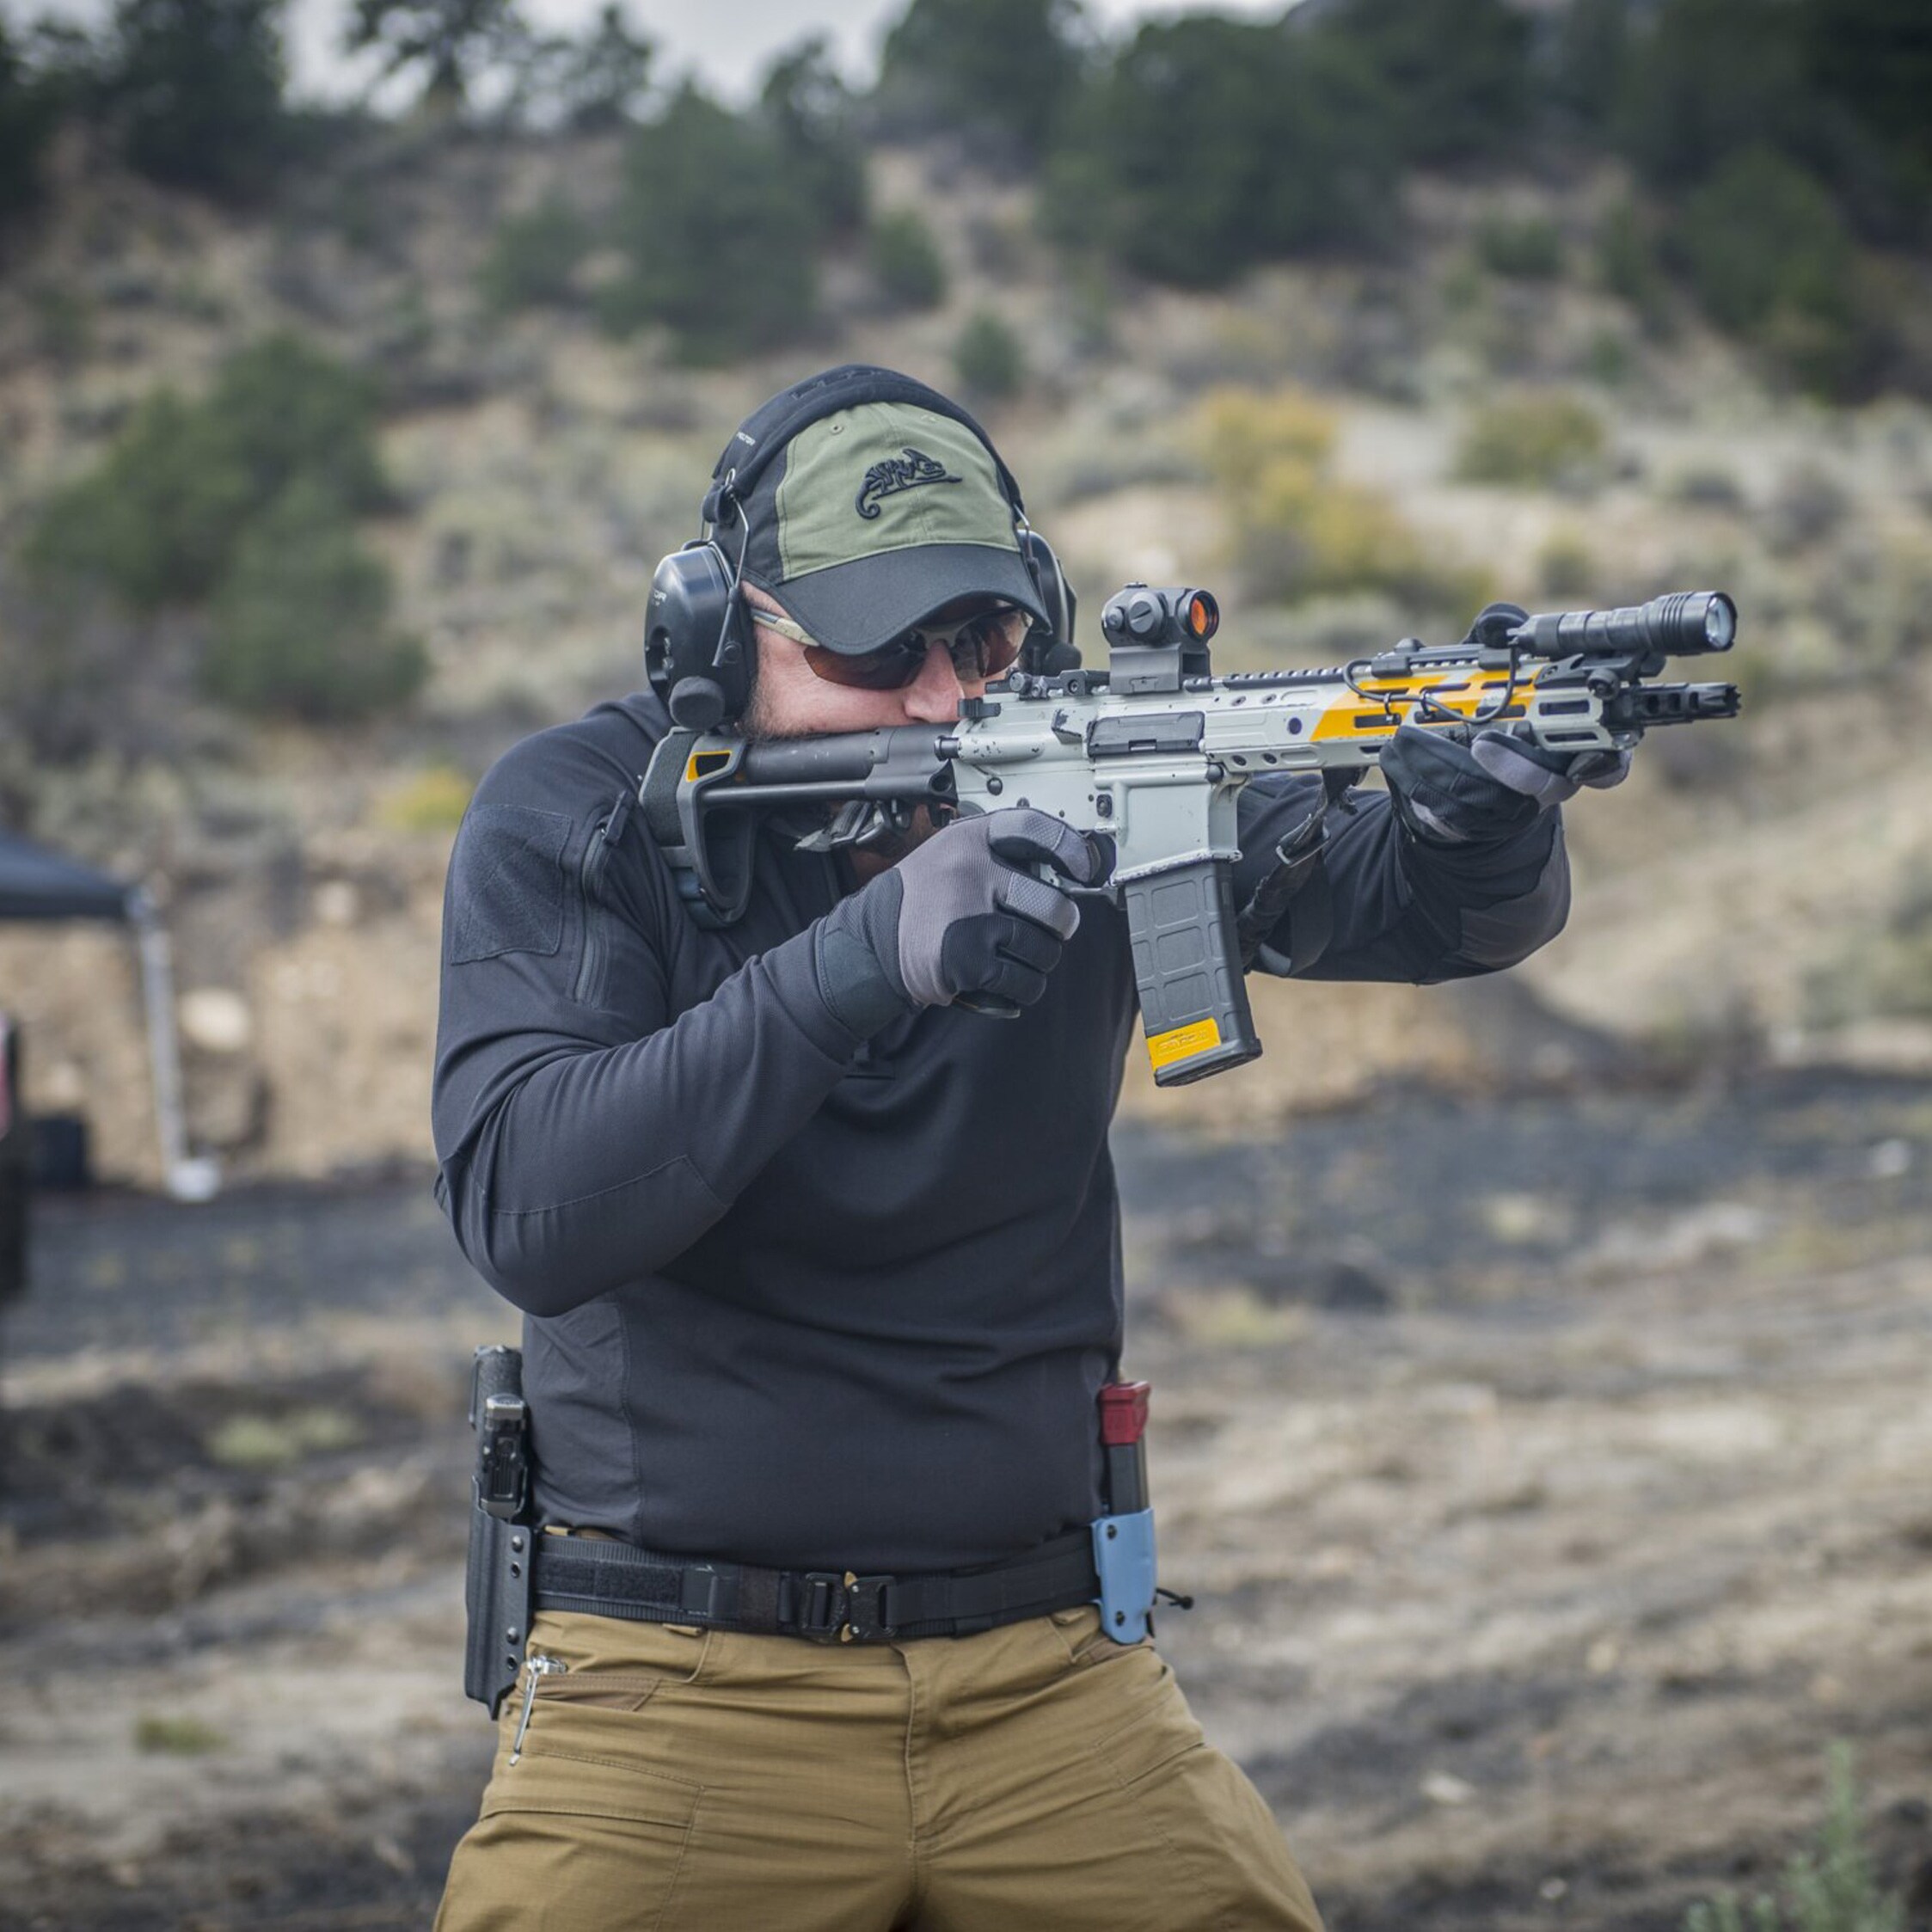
1235;776;1569;985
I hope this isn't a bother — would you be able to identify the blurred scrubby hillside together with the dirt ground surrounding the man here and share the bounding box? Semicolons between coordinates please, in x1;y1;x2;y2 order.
0;106;1932;1932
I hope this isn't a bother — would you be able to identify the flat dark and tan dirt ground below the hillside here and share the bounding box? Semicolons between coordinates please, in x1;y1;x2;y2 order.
0;1072;1932;1932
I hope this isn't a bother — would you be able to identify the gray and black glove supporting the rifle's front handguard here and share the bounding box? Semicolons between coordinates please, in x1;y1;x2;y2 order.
1382;725;1630;846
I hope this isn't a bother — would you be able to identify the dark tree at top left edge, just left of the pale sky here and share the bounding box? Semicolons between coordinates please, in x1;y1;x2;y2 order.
107;0;290;201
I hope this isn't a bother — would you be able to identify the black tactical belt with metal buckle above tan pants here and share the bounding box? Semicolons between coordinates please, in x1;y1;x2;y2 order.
533;1528;1100;1644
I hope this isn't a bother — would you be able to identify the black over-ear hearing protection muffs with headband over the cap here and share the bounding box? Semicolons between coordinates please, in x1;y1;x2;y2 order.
643;363;1080;733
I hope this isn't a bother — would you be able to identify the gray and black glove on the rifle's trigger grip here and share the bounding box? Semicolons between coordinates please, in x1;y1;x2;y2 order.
813;809;1103;1038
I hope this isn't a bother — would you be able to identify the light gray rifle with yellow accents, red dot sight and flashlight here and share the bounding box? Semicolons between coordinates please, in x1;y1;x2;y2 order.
641;584;1739;1086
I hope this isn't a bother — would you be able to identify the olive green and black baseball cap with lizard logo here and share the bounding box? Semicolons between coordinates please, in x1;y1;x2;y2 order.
705;363;1049;655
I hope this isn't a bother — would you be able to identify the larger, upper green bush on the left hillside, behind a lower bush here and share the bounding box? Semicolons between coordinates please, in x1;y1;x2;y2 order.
25;336;389;610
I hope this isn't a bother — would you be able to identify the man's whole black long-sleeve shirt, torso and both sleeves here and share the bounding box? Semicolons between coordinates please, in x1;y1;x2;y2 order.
432;696;1567;1573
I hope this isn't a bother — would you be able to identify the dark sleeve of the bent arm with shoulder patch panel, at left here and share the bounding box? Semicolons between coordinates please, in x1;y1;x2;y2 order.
431;727;860;1316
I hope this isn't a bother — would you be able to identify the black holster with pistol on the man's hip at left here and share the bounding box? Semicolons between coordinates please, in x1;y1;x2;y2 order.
463;1348;537;1718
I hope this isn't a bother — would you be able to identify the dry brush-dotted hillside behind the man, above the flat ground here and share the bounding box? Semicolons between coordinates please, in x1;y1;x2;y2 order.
0;130;1932;1182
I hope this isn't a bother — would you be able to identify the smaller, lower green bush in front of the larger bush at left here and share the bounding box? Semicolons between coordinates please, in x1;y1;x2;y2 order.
201;479;429;722
